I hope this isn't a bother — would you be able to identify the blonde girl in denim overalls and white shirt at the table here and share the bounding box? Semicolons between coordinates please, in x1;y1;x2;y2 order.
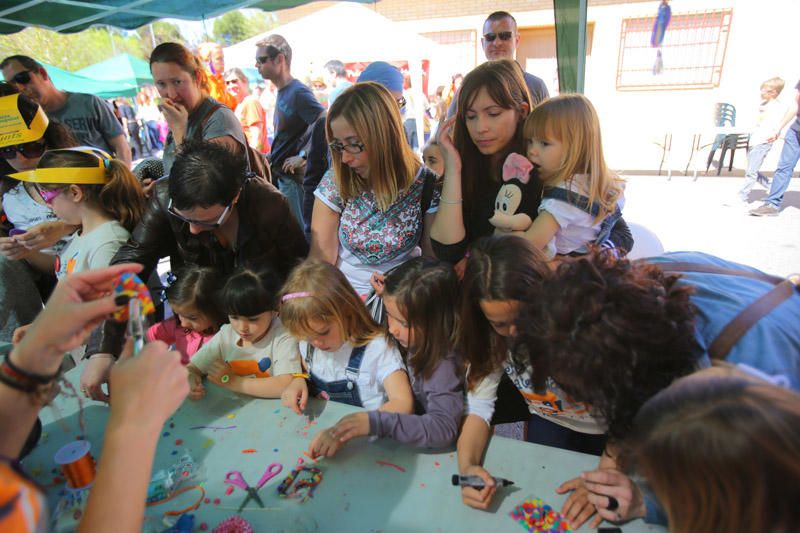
280;260;414;430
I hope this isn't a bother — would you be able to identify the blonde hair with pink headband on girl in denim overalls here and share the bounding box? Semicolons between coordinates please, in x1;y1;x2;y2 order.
280;259;382;346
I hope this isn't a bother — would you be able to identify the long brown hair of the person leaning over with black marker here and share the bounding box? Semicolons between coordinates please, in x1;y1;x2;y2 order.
460;235;550;388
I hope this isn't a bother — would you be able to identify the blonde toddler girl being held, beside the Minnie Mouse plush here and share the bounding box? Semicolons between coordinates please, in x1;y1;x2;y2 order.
520;94;624;257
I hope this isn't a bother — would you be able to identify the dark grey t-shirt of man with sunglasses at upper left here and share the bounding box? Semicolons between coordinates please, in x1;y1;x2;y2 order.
47;93;122;155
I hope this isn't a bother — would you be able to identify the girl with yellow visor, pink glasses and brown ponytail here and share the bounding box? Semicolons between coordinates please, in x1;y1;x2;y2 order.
11;146;144;278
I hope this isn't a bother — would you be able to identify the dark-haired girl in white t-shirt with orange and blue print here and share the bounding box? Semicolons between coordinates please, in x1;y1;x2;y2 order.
188;268;300;400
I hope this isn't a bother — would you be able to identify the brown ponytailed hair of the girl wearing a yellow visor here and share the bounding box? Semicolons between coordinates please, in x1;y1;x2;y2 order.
37;150;144;231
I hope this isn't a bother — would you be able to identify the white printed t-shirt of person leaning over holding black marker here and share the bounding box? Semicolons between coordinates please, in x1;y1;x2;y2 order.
467;353;606;434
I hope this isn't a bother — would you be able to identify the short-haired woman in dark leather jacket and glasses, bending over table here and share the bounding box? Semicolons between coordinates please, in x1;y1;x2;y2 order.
81;140;308;400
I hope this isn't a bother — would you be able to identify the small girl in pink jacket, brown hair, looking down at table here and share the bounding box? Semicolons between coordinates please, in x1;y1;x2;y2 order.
146;266;227;360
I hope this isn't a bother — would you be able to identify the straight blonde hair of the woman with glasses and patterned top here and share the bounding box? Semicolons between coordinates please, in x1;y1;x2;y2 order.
325;82;421;212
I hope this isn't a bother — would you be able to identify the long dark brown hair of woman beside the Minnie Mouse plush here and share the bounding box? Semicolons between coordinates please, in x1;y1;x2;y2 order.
453;59;533;240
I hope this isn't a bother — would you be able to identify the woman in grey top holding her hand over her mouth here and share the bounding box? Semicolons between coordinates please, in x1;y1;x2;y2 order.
150;43;247;174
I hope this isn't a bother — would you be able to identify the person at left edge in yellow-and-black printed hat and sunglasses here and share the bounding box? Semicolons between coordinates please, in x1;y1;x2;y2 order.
0;87;78;336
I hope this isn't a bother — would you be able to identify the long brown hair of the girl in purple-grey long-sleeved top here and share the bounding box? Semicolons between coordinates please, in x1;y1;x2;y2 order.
383;257;459;379
